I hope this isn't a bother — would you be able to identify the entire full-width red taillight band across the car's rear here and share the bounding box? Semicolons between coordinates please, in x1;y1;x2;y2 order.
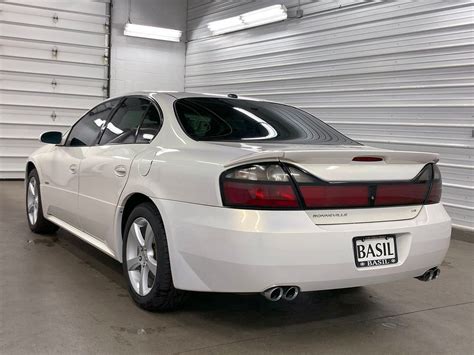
221;163;441;209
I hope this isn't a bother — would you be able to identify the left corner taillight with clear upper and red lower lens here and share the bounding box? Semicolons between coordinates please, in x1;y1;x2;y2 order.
221;164;300;209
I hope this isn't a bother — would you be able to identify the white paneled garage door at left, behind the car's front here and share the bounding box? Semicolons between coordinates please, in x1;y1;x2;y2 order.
0;0;110;179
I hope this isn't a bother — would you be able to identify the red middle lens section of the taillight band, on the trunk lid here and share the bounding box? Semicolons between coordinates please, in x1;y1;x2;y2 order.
299;185;369;208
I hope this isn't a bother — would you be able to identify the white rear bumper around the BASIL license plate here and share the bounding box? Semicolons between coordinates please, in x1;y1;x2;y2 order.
154;199;451;292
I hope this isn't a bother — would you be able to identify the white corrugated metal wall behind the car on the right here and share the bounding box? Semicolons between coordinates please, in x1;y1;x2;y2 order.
185;0;474;228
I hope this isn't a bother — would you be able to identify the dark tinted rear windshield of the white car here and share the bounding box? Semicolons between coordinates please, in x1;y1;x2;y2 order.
175;97;359;145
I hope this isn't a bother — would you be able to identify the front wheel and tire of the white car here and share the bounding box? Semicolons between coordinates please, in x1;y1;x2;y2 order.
25;169;59;234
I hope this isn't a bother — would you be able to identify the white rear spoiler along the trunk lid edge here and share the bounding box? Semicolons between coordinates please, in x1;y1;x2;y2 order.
225;148;439;167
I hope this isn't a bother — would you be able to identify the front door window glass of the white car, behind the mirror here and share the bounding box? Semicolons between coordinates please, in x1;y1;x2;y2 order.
66;99;120;147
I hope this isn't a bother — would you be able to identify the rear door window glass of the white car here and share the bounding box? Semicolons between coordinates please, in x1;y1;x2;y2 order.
99;97;150;145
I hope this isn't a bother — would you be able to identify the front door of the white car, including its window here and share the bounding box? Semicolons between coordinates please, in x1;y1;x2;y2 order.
42;100;118;227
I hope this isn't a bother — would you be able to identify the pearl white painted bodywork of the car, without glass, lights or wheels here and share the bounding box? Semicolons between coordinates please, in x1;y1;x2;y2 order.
29;92;451;292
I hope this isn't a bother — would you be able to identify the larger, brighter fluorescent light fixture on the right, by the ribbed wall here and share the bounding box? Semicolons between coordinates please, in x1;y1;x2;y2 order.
207;5;288;35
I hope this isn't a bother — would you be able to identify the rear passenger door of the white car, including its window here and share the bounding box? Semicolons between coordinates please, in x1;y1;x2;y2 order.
78;96;161;245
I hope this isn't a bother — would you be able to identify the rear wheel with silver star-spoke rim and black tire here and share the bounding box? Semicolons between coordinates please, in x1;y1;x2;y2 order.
122;202;186;312
